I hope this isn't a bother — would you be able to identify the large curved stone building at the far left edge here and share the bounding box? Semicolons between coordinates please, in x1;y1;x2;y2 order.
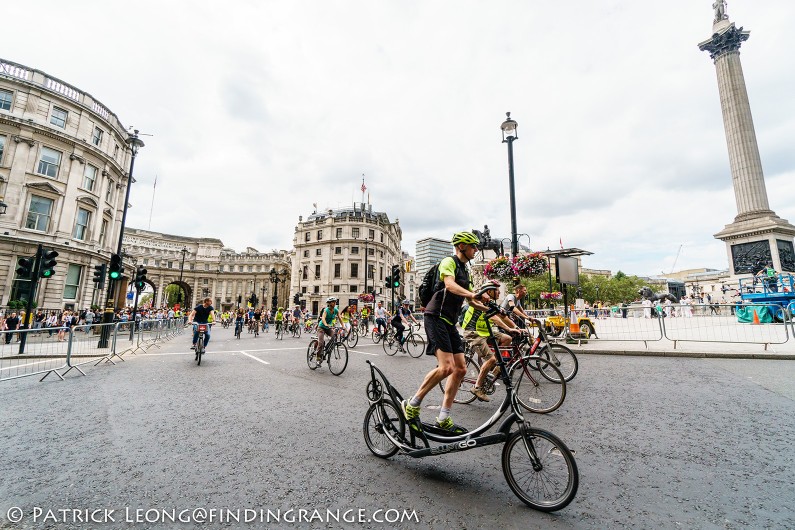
0;59;131;309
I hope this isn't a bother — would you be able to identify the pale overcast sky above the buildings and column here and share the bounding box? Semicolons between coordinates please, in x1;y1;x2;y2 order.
0;0;795;275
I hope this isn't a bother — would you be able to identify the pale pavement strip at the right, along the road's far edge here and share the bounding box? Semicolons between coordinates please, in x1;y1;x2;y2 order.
558;337;795;360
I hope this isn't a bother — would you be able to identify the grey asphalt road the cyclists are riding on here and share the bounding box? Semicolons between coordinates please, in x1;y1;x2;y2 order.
0;324;795;528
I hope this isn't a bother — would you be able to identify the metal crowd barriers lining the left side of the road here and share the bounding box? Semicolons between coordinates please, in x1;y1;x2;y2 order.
0;319;184;381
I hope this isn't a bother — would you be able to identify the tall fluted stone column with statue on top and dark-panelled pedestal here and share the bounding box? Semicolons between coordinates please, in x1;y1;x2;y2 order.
698;0;795;276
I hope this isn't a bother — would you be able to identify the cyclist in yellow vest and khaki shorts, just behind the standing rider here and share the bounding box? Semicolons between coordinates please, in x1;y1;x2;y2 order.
461;281;521;401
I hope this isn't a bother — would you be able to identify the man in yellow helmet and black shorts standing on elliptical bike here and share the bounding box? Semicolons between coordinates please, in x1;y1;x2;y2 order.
401;232;490;434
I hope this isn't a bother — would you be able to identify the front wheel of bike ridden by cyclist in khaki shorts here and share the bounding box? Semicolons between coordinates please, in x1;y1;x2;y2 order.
510;356;566;414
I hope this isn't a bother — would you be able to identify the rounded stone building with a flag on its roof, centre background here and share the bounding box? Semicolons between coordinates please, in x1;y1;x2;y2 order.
290;203;404;314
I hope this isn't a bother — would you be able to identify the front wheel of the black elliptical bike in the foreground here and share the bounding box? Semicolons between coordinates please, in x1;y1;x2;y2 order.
502;427;580;512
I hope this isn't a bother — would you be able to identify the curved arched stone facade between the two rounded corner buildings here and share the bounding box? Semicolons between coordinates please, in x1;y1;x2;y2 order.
123;228;292;310
